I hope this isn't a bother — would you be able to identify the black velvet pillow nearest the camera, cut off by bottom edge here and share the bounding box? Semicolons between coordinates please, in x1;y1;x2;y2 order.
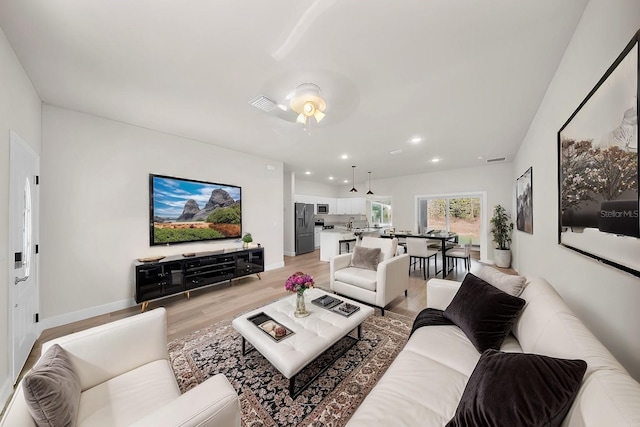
445;350;587;427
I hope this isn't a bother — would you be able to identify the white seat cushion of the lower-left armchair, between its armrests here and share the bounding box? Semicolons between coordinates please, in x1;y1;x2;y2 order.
78;359;180;427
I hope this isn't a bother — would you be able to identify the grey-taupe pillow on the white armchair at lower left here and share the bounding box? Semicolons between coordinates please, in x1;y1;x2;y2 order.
22;344;82;427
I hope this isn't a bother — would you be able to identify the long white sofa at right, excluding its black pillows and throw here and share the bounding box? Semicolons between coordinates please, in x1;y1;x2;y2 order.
347;277;640;427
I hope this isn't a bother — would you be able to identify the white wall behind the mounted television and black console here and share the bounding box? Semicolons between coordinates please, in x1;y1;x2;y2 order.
40;105;284;327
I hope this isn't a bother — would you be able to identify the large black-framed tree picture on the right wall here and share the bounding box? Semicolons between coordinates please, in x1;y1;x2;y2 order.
558;31;640;277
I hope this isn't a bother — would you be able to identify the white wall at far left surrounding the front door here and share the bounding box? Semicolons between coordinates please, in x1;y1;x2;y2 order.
0;29;41;403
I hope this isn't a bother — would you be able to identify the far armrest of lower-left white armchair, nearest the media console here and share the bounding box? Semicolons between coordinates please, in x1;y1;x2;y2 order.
42;307;168;391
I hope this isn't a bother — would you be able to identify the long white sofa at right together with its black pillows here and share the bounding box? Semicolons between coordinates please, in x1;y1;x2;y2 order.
347;267;640;427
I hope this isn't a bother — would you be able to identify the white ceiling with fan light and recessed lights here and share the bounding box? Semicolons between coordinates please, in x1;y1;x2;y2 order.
0;0;588;185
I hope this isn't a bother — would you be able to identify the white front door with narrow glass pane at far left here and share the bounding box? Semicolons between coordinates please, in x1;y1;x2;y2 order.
9;131;39;383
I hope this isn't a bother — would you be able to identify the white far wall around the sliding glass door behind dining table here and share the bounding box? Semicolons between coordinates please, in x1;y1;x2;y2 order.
371;163;515;260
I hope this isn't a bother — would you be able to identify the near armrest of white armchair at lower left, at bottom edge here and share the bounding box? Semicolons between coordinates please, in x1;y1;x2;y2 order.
133;374;241;427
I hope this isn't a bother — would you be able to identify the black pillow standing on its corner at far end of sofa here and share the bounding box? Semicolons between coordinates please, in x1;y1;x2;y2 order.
444;273;525;353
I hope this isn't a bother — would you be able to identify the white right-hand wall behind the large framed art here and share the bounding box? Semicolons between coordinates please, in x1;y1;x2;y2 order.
511;0;640;379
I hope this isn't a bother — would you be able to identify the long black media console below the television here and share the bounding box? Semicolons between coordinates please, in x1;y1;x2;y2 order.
135;248;264;311
